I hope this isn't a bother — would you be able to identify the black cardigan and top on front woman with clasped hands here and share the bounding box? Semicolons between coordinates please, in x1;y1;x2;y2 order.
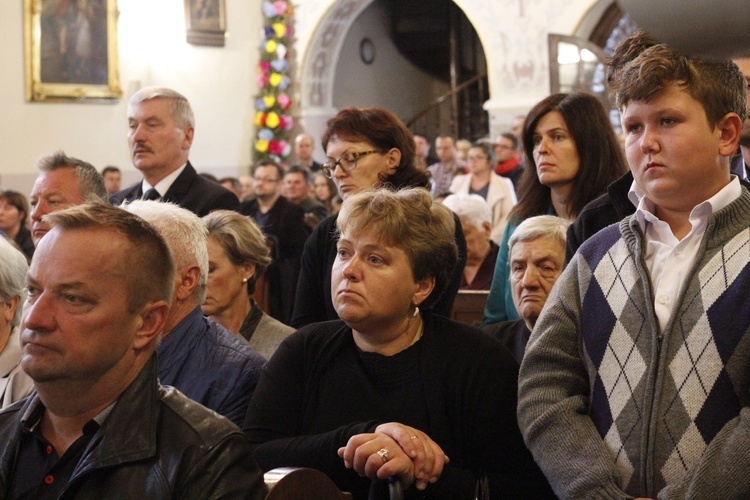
244;313;551;498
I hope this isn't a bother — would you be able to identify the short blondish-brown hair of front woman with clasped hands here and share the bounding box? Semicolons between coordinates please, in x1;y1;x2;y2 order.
336;188;458;308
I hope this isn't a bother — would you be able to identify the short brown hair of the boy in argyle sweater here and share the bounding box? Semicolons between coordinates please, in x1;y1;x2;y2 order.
610;33;747;127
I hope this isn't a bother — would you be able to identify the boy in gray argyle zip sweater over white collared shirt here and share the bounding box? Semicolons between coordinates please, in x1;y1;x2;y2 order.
518;34;750;499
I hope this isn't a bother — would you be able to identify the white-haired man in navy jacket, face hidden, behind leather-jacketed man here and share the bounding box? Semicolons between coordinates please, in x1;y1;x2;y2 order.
124;200;265;425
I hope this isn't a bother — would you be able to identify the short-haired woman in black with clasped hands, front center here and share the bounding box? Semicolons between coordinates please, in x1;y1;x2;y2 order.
244;188;551;499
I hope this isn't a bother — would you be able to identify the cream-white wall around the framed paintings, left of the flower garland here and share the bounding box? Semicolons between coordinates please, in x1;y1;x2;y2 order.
0;0;262;193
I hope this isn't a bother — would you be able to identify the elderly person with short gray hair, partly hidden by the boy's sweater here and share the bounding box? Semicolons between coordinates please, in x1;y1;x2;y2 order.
485;215;570;363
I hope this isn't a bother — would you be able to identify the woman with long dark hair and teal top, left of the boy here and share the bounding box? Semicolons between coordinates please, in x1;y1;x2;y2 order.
483;92;628;325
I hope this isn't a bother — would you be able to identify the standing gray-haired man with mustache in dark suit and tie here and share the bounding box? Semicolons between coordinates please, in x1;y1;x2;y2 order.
110;87;239;217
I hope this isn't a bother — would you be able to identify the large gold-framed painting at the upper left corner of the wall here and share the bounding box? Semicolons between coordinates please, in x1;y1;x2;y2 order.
24;0;122;102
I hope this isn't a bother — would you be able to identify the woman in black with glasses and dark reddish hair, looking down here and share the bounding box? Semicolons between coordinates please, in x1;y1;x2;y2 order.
290;107;466;328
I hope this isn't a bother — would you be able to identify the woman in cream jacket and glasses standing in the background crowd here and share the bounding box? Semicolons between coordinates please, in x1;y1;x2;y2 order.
449;142;516;245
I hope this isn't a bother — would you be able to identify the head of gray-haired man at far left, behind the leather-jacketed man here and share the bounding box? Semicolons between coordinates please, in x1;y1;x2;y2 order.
29;151;107;246
